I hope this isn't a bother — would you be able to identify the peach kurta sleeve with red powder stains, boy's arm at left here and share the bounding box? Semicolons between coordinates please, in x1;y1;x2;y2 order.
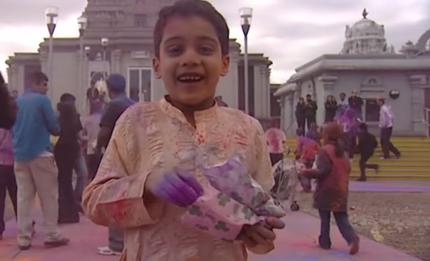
83;111;156;228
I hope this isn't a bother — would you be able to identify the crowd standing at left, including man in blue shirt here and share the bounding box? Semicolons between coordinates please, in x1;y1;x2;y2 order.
0;68;133;252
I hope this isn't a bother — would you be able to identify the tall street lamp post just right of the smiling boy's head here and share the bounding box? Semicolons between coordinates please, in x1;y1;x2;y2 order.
239;7;252;113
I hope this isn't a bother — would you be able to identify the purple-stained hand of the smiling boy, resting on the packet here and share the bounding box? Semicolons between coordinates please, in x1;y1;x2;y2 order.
145;169;203;207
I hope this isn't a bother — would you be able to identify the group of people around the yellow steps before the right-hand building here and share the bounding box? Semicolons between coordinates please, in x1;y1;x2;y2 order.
295;90;401;181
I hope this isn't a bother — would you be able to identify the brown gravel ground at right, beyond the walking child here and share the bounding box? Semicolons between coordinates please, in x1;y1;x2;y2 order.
299;192;430;261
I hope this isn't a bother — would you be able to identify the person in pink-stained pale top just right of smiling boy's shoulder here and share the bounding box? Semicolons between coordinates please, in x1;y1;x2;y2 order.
265;120;287;166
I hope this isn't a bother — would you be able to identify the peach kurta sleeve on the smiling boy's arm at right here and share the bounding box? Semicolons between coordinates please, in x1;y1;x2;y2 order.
252;120;275;191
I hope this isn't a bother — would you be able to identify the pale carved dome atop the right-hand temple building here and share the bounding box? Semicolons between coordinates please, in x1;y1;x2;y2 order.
341;9;393;54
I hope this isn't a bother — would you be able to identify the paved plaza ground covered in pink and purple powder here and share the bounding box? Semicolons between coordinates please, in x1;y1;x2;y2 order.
0;182;430;261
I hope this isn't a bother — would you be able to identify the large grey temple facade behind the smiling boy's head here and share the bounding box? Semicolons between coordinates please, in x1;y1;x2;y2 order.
7;0;272;119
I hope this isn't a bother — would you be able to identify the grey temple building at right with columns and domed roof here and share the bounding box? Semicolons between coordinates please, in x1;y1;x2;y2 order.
275;10;430;136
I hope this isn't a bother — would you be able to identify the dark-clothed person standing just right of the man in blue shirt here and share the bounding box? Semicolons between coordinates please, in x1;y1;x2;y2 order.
54;93;82;224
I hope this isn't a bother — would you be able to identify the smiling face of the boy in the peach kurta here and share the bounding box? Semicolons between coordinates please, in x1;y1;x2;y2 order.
153;16;230;106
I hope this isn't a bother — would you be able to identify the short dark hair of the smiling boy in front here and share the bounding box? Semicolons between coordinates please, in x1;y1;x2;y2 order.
154;0;230;57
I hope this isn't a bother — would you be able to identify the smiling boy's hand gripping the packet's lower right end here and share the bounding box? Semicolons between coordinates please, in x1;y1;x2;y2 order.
237;217;285;248
